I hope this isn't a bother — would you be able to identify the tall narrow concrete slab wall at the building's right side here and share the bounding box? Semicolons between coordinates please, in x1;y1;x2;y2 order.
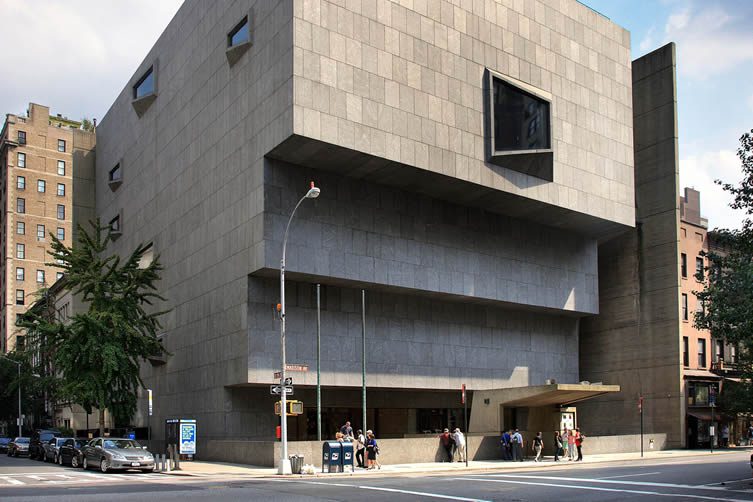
578;44;685;447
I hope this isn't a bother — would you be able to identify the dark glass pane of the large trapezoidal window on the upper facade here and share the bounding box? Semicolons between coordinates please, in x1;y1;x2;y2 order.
492;78;551;151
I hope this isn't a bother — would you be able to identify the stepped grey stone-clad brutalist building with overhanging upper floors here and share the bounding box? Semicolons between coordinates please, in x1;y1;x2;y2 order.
96;0;635;463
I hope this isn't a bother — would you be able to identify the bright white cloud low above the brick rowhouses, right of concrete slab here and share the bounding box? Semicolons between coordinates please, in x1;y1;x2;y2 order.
680;150;744;228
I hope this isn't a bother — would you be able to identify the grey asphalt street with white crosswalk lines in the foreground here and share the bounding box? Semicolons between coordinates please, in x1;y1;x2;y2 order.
0;451;753;502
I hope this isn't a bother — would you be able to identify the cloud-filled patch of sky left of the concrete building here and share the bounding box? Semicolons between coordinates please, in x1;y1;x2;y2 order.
0;0;183;118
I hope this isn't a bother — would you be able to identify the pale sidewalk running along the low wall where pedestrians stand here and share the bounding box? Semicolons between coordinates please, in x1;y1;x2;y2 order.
162;447;753;477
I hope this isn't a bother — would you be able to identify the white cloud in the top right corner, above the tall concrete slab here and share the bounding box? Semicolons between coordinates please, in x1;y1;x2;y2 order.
664;0;753;79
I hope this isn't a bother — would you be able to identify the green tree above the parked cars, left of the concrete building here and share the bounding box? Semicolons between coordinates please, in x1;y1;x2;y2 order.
21;221;166;434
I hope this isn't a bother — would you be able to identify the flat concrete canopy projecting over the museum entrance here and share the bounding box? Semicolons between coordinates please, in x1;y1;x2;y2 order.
484;383;620;407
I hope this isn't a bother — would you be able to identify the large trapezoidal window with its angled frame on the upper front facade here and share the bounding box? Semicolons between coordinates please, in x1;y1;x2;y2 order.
487;71;554;181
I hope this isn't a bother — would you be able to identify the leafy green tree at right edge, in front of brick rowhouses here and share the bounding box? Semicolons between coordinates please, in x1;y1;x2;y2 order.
694;130;753;413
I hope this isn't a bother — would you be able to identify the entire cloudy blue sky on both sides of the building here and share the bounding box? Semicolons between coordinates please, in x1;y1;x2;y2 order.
0;0;753;228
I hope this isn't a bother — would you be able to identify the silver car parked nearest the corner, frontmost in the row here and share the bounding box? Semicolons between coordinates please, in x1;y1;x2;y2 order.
82;438;154;472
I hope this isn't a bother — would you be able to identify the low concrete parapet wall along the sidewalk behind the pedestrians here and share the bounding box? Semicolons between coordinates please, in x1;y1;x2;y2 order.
197;434;666;467
